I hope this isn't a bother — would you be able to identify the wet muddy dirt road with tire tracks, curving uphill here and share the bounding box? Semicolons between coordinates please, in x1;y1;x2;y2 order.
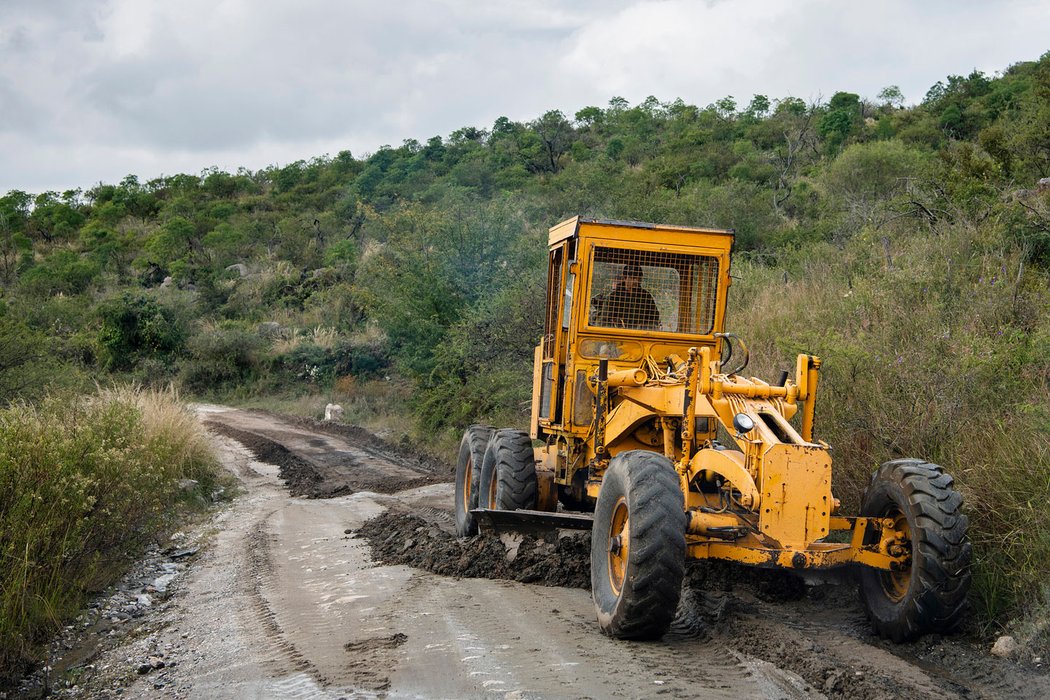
30;406;1050;699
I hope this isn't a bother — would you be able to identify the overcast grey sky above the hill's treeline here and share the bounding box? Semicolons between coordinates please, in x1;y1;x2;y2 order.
0;0;1050;193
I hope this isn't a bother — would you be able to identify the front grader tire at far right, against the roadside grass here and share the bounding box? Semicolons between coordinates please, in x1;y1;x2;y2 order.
860;460;971;642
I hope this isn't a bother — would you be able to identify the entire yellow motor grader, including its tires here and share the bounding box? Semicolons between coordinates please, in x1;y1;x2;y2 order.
456;217;970;641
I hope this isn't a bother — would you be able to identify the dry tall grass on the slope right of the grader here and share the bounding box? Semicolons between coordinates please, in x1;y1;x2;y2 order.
729;224;1050;631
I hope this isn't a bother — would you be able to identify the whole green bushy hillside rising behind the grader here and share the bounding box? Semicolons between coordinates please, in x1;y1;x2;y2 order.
0;54;1050;621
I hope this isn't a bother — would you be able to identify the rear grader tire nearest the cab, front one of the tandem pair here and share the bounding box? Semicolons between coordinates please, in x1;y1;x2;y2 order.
478;428;537;510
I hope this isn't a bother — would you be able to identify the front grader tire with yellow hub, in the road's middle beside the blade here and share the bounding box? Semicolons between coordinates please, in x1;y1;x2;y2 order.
591;450;686;639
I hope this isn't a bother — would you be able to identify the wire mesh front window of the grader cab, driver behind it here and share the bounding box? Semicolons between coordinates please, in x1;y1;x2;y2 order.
589;248;718;335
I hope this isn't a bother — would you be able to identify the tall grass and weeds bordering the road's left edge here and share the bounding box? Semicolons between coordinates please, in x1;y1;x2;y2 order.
0;387;222;682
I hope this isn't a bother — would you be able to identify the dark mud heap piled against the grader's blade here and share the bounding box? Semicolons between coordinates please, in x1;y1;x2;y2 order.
356;511;590;589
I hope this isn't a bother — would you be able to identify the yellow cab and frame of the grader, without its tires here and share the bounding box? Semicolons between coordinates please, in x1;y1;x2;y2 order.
530;217;907;570
